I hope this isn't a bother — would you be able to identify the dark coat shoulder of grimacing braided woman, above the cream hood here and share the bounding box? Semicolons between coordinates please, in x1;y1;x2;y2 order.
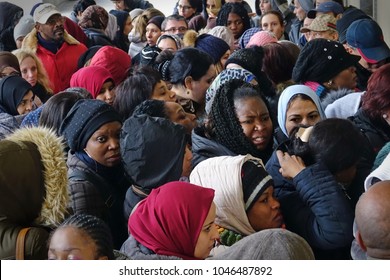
191;127;236;168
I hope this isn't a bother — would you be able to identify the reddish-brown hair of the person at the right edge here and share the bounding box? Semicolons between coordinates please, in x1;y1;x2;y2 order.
362;64;390;120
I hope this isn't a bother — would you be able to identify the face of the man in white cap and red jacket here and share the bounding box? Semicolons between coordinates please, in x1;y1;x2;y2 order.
35;14;65;42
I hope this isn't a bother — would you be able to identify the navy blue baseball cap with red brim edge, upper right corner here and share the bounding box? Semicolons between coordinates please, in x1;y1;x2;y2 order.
346;19;390;63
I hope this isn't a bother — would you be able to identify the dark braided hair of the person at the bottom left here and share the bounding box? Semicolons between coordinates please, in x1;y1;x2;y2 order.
49;214;115;260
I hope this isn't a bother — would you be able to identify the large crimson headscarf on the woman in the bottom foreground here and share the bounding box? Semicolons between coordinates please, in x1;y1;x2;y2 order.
129;182;214;260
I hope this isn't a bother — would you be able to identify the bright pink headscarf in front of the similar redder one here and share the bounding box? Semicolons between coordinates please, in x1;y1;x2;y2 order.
70;66;114;99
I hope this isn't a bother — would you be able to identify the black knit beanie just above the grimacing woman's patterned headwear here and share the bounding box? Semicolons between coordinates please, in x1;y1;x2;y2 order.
225;46;264;81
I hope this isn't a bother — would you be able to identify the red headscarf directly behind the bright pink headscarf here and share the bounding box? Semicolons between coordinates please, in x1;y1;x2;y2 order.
90;46;131;85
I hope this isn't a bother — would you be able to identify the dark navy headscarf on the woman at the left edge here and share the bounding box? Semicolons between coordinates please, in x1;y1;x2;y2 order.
0;76;32;116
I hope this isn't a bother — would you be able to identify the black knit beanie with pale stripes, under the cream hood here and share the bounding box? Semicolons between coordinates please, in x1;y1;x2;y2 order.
241;160;274;212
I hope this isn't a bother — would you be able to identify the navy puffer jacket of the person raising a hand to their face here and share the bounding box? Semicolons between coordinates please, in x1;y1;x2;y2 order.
266;152;354;259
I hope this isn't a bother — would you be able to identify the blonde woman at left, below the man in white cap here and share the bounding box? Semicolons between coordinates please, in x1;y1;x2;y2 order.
13;49;53;103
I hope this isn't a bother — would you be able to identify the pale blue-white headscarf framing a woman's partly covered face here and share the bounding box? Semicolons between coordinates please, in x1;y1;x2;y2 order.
278;85;326;137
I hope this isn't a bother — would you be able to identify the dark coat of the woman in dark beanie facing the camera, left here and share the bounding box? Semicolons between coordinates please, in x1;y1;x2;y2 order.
67;151;128;249
